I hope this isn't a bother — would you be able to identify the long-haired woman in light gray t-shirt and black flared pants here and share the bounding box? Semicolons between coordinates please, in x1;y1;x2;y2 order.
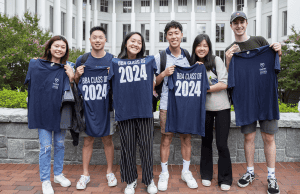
192;34;232;190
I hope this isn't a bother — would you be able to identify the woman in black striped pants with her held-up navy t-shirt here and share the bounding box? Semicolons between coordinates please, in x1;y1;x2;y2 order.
108;32;157;194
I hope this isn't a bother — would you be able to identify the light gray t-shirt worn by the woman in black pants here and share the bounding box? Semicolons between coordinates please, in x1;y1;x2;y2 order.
205;56;230;111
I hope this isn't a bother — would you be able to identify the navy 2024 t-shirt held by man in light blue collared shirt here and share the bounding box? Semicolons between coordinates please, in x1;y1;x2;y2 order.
165;64;210;136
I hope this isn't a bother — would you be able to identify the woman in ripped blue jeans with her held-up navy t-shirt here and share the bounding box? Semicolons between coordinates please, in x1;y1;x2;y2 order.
25;36;74;194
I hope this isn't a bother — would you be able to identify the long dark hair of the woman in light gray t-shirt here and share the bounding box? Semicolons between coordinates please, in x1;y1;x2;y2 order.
191;34;215;71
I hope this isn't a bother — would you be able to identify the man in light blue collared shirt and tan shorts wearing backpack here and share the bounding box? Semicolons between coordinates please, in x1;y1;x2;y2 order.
155;21;198;191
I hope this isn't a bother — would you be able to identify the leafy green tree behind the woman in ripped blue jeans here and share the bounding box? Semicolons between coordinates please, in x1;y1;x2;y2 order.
0;12;51;90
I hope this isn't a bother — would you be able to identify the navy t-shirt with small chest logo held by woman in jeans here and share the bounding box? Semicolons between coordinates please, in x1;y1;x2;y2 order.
24;59;70;132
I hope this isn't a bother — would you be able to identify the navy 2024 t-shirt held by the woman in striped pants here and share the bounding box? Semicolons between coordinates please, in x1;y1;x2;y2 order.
109;56;157;121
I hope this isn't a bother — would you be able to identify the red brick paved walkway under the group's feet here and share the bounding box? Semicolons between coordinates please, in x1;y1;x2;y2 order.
0;162;300;194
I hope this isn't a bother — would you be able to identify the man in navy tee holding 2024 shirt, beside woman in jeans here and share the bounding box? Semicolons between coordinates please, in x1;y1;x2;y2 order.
75;26;117;189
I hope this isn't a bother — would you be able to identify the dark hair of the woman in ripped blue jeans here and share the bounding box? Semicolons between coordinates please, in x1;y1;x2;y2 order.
41;35;69;64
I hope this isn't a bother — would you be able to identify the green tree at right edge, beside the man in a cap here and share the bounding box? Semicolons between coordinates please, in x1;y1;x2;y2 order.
278;26;300;103
